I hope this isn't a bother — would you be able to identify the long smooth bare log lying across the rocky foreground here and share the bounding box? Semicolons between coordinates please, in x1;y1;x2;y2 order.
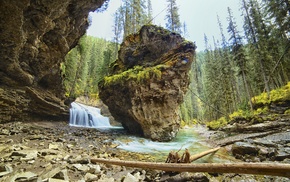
91;158;290;177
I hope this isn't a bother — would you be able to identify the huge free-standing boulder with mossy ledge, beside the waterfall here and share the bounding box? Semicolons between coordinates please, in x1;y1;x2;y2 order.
99;25;196;141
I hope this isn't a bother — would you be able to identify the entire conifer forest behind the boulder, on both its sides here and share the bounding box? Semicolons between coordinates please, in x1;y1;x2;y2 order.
61;0;290;124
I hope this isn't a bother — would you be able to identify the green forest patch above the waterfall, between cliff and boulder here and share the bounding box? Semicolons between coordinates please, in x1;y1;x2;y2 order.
61;35;116;97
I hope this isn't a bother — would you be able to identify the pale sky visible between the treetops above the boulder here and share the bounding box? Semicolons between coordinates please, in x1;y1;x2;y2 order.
87;0;243;51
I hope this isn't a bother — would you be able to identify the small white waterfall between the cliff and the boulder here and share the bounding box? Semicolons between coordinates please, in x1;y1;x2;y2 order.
69;102;111;128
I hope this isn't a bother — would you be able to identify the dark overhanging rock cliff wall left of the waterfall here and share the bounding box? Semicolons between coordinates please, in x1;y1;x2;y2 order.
0;0;105;122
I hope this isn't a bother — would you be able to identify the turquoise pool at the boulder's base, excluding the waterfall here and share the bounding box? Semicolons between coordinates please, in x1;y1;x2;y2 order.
115;128;234;163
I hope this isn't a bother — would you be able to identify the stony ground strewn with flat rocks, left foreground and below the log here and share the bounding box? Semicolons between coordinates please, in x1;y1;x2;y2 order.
0;121;289;182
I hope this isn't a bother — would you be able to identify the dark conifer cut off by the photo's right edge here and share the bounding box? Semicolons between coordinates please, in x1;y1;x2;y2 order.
263;0;290;86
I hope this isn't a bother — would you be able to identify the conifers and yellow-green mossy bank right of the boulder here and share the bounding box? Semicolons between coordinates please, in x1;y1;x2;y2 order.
193;0;290;121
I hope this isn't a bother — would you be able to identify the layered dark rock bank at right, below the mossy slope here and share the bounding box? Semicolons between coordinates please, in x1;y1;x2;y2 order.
209;114;290;163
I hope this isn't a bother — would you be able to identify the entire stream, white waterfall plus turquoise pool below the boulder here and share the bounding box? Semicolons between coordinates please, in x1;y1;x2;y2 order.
70;103;234;163
